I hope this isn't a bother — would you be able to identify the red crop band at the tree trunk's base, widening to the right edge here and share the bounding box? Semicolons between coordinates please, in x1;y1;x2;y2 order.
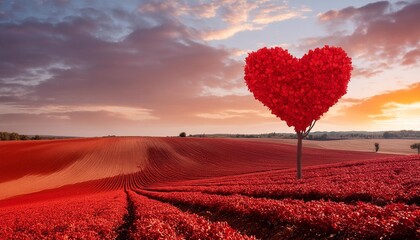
149;156;420;205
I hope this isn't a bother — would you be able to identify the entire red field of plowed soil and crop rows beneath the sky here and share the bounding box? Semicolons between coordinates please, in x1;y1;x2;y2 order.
0;137;420;239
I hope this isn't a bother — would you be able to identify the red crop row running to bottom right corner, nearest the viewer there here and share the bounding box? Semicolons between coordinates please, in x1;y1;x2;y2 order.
138;190;420;239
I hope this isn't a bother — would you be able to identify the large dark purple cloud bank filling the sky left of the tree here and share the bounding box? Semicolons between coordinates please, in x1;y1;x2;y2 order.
0;2;261;135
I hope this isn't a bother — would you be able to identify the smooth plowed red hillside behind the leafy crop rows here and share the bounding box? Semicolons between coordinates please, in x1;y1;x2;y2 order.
0;137;396;204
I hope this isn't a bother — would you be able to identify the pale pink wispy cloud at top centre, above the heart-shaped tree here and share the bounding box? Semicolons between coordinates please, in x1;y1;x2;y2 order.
139;0;310;41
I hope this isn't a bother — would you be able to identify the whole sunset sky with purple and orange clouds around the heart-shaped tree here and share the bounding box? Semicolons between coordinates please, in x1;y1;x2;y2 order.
0;0;420;136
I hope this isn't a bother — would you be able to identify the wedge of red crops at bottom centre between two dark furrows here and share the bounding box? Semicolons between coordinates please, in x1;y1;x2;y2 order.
128;192;254;240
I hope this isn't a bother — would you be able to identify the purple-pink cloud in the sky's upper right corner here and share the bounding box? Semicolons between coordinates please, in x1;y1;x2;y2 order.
303;1;420;69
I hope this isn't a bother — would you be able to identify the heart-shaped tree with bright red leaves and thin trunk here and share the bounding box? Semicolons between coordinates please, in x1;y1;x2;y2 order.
245;46;352;179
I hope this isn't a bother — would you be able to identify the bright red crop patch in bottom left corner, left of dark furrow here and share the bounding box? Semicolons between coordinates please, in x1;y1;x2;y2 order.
0;191;127;239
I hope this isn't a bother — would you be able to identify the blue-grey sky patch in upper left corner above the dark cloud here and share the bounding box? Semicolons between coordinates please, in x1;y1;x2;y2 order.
0;0;146;41
